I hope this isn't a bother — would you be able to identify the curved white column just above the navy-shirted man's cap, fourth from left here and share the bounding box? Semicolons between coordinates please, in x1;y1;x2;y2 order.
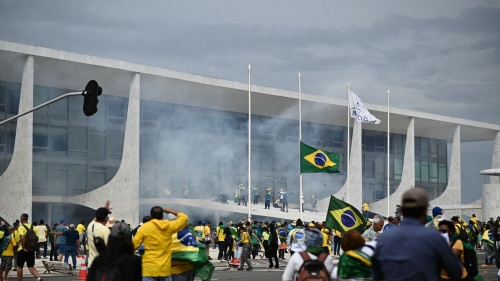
370;117;415;215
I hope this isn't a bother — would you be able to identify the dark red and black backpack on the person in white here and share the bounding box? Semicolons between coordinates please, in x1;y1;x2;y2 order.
296;252;330;281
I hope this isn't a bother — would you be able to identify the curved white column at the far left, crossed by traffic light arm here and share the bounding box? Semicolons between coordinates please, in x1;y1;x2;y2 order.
0;56;34;223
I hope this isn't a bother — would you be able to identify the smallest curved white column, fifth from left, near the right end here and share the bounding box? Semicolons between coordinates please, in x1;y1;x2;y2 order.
429;125;462;206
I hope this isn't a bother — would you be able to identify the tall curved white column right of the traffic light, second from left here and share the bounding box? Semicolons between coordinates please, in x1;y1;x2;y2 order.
68;73;141;225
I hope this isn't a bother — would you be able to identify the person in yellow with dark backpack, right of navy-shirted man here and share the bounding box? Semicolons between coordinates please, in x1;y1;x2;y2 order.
439;220;478;280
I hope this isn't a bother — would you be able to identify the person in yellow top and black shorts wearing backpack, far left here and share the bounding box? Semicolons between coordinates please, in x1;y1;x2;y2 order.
17;213;43;281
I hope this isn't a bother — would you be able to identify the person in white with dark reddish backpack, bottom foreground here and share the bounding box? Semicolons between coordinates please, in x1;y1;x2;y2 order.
281;229;334;281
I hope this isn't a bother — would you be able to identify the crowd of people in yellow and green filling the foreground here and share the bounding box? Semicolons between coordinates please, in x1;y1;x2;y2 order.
0;188;500;281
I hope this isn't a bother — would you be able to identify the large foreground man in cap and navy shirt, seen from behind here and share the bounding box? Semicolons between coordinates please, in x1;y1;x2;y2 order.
372;188;462;281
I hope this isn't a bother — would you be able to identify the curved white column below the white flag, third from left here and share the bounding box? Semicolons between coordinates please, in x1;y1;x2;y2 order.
318;118;363;210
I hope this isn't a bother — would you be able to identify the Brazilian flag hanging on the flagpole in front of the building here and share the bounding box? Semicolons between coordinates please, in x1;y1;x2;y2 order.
300;141;339;173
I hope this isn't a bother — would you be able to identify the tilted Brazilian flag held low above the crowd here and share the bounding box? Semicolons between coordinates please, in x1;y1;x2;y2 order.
325;196;366;233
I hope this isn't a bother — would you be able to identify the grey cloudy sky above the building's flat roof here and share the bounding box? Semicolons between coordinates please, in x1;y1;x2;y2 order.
0;0;500;202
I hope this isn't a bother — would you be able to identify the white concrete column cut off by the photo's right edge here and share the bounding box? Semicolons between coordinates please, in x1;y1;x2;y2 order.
482;132;500;221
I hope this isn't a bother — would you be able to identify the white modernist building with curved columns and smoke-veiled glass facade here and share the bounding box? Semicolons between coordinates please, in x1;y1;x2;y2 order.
0;41;500;224
